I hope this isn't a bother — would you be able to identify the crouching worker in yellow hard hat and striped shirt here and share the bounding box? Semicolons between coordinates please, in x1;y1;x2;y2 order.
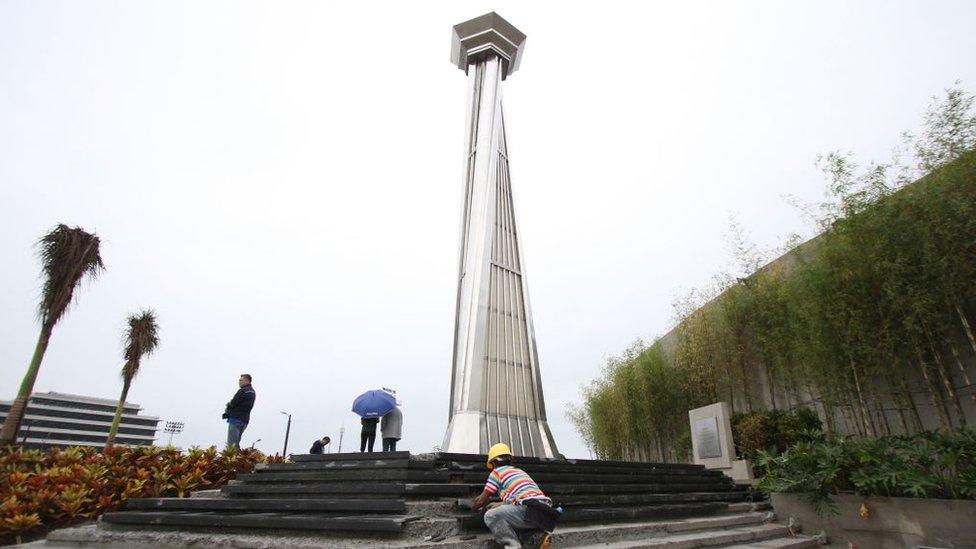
471;443;558;549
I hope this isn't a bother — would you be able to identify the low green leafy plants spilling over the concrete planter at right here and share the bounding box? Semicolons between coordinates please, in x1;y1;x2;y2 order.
758;428;976;515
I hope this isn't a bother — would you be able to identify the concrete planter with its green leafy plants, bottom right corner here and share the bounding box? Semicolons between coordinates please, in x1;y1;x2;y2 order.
759;428;976;548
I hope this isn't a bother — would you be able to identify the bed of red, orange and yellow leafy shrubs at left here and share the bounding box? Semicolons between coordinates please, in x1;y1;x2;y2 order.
0;446;281;543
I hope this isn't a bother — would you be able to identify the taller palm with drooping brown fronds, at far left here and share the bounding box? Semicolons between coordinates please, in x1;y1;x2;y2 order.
0;224;105;445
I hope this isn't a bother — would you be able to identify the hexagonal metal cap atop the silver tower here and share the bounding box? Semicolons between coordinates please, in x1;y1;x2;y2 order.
451;12;525;78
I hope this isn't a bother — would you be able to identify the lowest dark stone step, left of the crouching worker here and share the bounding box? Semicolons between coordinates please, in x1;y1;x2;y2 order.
100;511;420;532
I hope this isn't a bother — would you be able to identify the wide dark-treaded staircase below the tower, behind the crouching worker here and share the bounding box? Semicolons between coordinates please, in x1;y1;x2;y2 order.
48;452;812;549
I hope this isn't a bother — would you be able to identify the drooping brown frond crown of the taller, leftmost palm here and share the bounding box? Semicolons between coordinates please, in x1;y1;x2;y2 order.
37;223;105;327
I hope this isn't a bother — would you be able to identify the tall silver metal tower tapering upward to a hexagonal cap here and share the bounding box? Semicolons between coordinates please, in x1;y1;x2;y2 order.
442;13;557;457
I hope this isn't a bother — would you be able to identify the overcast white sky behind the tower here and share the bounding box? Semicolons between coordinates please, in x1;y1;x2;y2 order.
0;0;976;457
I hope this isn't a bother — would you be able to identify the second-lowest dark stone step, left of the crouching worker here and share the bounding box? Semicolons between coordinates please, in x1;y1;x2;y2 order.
125;498;407;514
